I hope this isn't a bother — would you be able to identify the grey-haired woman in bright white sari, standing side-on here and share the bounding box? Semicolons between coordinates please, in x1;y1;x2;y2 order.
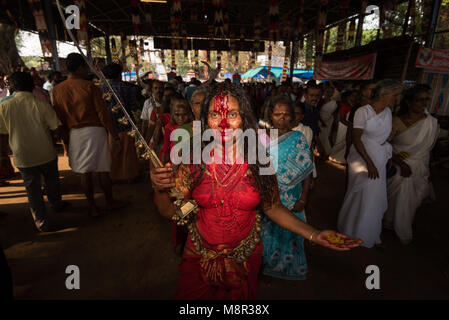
338;80;401;248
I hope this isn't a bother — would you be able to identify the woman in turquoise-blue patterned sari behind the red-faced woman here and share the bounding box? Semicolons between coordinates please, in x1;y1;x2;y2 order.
261;96;313;280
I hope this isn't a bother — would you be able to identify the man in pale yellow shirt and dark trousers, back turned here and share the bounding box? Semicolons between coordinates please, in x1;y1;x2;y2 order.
0;72;66;231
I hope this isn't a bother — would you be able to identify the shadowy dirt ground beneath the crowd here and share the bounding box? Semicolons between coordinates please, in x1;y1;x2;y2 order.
0;156;449;300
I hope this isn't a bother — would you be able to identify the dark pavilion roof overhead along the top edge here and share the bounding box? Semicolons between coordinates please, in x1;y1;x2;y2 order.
0;0;402;44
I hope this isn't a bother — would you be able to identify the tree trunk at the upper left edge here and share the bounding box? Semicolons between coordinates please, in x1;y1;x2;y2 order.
0;23;25;74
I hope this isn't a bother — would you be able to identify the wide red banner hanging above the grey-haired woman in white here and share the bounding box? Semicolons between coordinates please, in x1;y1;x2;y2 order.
314;53;377;80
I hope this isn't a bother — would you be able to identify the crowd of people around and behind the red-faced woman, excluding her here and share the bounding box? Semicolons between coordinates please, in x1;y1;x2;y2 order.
0;54;448;300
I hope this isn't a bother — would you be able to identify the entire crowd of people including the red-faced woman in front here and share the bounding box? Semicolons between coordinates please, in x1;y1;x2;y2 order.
0;54;438;299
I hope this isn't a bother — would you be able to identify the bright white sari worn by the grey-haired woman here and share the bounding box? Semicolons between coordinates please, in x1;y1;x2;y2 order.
338;104;392;248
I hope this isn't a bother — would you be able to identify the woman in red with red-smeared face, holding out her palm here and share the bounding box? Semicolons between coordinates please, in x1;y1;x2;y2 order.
151;83;360;299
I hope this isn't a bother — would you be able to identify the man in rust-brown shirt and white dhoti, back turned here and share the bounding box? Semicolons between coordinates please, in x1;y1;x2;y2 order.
52;53;125;217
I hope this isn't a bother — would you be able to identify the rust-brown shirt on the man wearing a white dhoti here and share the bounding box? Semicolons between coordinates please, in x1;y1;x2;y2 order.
52;75;114;132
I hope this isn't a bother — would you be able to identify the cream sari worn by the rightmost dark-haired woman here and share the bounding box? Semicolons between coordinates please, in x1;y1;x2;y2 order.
384;113;438;242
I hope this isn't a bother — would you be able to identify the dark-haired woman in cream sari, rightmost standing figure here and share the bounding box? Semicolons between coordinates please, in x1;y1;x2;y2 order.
384;85;439;244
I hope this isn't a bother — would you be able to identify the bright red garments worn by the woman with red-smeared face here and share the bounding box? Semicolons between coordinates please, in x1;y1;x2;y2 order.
175;164;263;300
